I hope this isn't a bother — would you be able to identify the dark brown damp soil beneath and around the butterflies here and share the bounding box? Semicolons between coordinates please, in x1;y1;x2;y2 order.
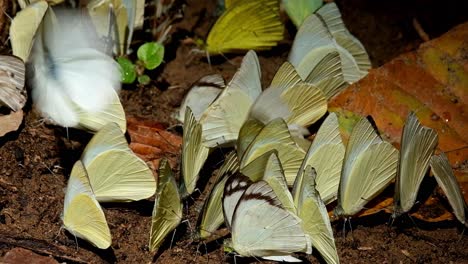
0;0;468;264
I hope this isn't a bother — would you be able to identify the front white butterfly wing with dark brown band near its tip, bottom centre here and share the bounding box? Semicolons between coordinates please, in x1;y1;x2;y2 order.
232;181;311;257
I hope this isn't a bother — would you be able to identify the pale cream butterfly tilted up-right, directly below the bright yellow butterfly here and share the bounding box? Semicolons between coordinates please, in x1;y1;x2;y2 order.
199;51;262;148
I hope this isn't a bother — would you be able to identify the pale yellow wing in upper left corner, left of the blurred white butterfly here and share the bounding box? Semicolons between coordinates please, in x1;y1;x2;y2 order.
10;1;49;62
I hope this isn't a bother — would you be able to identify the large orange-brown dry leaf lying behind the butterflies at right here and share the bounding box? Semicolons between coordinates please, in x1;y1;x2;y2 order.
329;22;468;221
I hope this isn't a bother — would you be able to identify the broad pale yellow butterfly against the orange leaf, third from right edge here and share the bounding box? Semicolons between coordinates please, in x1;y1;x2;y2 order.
334;118;398;217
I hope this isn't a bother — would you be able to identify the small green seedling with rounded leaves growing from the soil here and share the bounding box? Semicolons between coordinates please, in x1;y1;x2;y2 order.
117;42;164;84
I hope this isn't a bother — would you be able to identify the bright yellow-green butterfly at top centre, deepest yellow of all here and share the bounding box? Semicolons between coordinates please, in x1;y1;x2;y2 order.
205;0;284;54
